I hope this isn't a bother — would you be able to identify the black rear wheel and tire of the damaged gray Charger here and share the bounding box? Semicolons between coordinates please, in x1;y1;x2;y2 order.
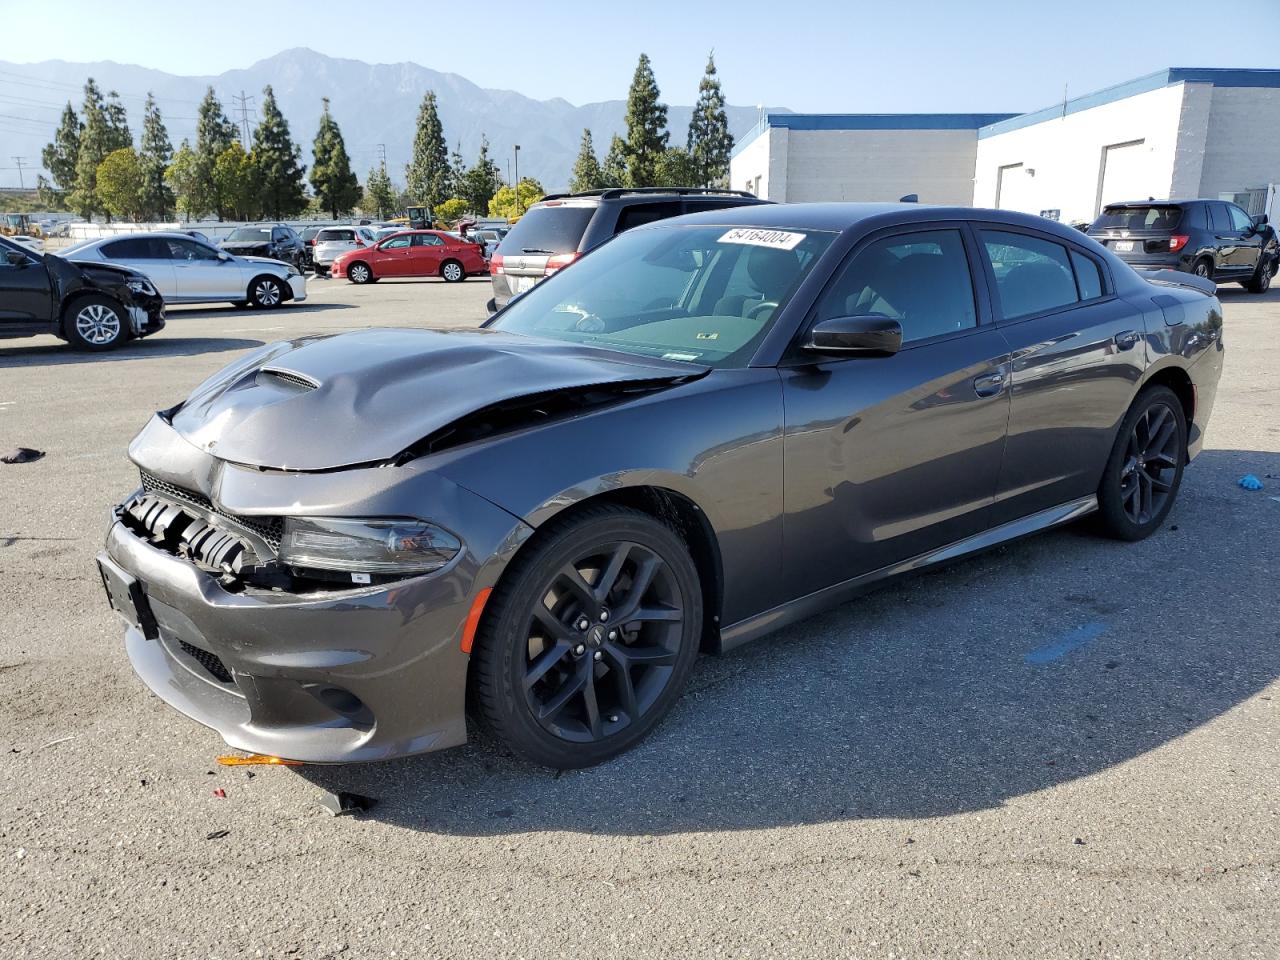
1098;387;1187;540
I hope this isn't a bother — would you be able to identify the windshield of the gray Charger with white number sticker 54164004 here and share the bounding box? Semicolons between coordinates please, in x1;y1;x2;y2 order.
490;227;835;366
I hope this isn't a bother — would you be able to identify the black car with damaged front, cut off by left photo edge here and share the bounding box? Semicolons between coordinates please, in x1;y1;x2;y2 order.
0;238;164;349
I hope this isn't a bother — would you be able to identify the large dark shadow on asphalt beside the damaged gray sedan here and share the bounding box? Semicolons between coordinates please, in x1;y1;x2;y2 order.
296;451;1280;836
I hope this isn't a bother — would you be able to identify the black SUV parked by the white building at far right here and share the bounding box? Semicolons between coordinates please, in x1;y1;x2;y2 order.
1088;200;1280;293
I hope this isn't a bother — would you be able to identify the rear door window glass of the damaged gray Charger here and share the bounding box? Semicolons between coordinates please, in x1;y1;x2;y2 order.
982;230;1080;320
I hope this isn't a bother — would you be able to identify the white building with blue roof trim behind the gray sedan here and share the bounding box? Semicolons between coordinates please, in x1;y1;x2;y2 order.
730;68;1280;221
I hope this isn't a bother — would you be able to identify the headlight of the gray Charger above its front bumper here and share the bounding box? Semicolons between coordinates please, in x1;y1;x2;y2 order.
279;517;462;575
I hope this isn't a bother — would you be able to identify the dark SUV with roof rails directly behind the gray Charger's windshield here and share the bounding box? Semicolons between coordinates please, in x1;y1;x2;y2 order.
489;187;769;314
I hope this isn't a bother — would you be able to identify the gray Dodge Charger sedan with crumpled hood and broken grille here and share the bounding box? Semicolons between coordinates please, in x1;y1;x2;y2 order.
99;204;1222;767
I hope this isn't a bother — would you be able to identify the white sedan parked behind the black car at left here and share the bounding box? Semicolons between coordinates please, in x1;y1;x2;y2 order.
59;233;307;308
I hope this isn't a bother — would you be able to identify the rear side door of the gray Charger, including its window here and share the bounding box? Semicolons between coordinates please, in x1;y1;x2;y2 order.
977;224;1162;524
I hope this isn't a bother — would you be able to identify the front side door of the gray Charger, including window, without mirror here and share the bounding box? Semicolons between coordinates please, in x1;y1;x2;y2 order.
781;221;1009;595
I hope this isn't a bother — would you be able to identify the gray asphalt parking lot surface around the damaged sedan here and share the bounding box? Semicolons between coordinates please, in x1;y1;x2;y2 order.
0;273;1280;960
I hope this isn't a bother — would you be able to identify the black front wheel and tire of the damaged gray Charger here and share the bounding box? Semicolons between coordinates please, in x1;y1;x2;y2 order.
471;506;703;769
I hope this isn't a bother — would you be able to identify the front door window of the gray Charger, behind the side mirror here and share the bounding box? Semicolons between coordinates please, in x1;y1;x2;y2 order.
818;230;972;342
